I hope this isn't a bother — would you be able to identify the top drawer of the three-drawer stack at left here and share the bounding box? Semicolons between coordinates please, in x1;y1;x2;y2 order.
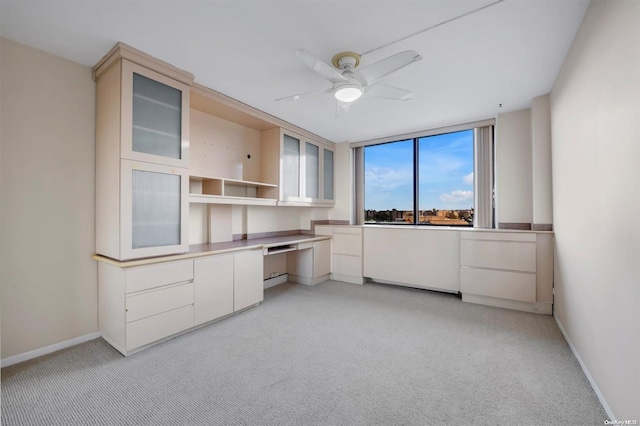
125;260;193;293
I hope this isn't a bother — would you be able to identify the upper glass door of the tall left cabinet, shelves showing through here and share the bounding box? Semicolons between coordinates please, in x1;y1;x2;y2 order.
122;61;189;167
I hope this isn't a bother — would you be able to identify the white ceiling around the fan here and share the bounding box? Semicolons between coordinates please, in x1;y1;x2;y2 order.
0;0;588;142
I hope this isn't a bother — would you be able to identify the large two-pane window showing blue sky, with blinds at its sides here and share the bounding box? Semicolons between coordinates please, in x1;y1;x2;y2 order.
356;122;493;227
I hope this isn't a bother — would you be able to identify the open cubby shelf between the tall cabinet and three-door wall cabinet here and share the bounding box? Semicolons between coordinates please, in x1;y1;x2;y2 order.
189;176;278;206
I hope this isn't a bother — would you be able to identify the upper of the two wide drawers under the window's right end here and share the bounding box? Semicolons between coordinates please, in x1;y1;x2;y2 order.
460;240;536;272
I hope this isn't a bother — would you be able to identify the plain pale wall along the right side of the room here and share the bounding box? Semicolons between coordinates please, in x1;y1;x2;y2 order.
551;0;640;421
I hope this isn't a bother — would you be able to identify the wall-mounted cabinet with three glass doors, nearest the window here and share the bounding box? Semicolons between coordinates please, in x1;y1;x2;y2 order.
261;128;335;206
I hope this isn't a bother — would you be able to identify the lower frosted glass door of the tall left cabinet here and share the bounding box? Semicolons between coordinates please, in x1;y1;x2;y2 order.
120;160;189;259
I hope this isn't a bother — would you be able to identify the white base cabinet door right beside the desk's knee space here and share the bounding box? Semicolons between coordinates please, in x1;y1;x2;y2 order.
233;250;264;311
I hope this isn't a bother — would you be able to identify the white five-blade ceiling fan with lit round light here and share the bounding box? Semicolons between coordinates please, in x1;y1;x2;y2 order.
276;49;422;115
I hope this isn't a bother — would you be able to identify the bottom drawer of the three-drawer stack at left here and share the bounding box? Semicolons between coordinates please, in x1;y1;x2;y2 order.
127;306;193;351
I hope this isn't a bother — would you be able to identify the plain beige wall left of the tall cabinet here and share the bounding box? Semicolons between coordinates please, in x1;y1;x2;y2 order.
0;39;98;359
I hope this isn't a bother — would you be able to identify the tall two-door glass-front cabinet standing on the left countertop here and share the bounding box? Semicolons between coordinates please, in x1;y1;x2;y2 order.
93;43;193;260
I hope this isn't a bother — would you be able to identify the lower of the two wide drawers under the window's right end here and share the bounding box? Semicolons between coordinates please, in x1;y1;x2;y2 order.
460;267;536;302
